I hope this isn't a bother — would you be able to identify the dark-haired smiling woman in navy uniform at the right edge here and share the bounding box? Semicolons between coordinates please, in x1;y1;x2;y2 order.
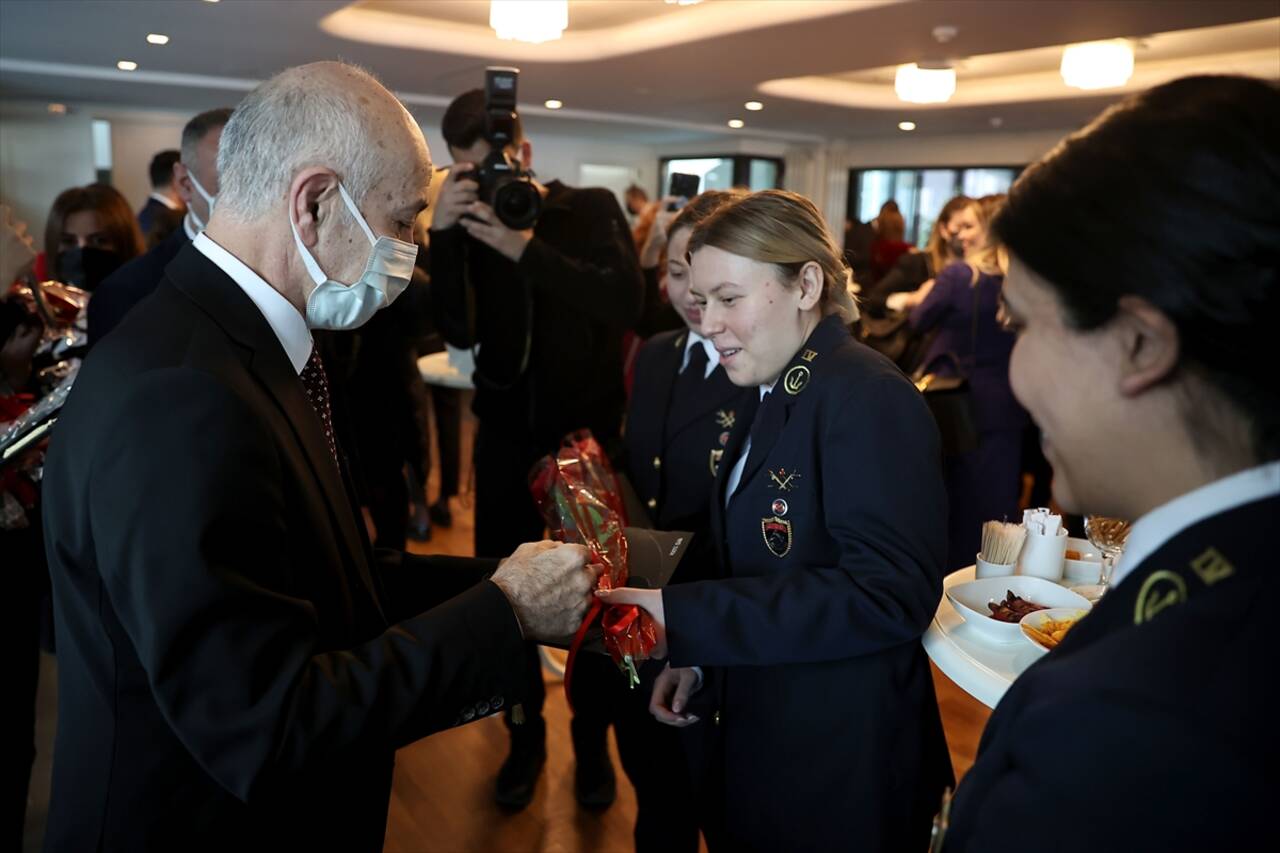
943;77;1280;853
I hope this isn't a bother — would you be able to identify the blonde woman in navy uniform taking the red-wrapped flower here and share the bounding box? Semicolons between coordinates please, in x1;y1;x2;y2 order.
607;190;952;850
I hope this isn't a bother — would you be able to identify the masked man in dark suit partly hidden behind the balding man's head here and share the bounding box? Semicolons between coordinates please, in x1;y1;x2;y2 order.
88;106;232;346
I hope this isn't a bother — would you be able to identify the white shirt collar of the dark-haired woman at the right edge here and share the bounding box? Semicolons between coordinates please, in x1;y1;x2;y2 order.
1111;462;1280;585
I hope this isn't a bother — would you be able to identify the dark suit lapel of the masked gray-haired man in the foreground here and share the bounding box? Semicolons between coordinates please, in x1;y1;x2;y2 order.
166;246;376;599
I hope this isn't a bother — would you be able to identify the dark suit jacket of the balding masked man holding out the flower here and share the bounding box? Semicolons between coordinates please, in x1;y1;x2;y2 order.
45;247;525;850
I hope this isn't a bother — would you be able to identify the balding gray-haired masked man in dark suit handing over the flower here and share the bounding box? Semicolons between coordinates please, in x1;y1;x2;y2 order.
45;63;594;850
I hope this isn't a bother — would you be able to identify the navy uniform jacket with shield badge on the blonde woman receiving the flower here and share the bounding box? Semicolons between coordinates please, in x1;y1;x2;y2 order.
663;318;951;850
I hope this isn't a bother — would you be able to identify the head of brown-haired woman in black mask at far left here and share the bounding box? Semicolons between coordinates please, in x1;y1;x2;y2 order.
37;183;146;291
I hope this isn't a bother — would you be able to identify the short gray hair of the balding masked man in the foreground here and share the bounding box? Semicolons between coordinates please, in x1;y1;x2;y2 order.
218;64;381;222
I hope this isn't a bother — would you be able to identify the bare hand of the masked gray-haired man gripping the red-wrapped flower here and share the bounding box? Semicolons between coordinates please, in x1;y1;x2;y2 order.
493;542;600;643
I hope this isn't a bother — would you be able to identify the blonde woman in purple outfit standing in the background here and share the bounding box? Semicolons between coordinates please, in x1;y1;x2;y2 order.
908;196;1028;563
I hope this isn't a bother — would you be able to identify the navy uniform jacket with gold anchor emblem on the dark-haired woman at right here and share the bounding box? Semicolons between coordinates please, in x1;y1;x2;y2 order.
942;497;1280;853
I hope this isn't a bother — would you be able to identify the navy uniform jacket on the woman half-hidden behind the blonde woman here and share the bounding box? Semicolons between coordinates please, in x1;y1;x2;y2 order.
626;329;754;533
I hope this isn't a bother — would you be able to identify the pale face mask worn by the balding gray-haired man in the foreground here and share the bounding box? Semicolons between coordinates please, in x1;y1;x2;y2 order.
289;183;417;329
